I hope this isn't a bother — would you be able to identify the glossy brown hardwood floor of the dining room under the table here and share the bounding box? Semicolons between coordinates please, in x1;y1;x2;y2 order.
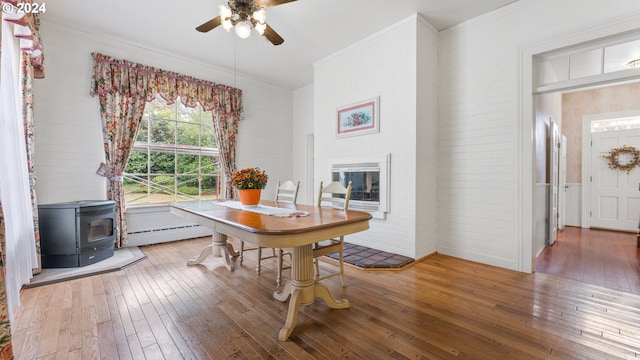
13;238;640;360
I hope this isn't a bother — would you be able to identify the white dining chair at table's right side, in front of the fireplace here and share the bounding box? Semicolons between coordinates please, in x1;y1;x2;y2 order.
313;181;352;286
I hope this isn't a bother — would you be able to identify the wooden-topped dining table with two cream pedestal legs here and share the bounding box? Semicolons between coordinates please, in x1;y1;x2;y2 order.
170;200;372;341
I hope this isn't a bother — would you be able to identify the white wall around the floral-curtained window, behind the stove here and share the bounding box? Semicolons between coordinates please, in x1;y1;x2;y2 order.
34;22;292;203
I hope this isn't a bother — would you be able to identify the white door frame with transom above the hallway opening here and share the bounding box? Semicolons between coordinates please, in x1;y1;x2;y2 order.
519;24;640;272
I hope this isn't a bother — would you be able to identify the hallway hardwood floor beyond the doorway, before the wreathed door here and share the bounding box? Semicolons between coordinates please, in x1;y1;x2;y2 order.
536;227;640;294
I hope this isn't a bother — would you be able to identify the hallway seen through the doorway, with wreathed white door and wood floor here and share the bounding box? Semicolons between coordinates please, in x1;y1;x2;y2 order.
536;82;640;291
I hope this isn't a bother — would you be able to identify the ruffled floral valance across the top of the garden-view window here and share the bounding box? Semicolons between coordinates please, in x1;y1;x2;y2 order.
91;53;243;119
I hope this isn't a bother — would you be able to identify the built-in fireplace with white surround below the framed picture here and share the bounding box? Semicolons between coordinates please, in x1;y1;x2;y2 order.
331;155;390;218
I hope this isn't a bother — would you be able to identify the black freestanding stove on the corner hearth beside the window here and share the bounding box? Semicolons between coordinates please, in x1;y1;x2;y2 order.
38;200;116;268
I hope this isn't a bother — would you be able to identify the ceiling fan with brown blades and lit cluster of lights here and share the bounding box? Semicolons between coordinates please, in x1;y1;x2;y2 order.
196;0;296;45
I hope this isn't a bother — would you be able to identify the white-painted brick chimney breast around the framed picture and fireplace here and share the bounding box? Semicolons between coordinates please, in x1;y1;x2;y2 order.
313;15;437;258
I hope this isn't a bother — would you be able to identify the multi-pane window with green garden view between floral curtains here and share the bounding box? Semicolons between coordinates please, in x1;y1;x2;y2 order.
123;97;221;206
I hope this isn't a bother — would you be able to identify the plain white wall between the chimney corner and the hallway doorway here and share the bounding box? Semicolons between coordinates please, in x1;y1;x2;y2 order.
437;0;640;271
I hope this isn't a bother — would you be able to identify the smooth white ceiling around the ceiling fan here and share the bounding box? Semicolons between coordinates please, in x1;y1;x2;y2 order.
41;0;516;89
